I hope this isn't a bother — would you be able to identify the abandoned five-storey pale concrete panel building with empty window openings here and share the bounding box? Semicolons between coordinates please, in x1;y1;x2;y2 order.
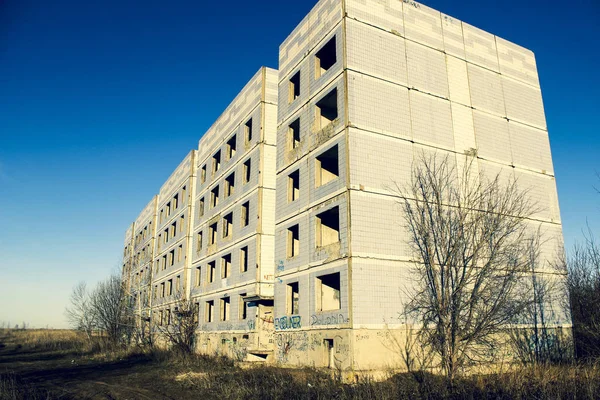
124;0;569;371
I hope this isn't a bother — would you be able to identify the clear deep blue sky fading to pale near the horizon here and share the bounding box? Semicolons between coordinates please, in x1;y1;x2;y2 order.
0;0;600;327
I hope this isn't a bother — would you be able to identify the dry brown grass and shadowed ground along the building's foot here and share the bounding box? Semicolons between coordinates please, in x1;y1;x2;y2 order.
0;330;600;400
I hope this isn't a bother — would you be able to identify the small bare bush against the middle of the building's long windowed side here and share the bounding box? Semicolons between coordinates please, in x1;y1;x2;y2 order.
157;292;199;355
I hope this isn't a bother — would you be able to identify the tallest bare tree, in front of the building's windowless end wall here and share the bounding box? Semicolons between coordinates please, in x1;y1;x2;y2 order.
397;155;537;381
